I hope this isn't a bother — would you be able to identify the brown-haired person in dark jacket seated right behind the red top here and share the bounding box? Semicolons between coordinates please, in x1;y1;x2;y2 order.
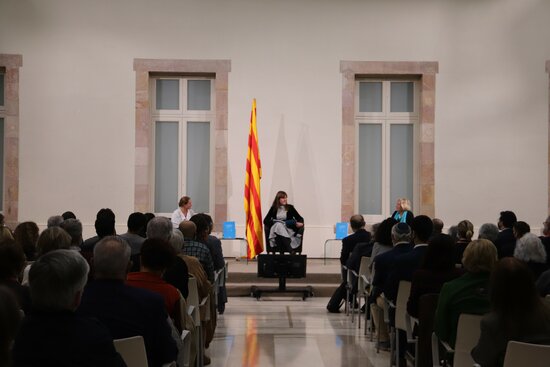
78;236;178;367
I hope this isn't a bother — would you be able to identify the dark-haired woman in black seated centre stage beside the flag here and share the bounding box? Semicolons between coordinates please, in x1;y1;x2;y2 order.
264;191;304;254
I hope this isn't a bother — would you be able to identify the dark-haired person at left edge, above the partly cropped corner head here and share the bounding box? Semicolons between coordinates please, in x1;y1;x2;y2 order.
0;239;31;314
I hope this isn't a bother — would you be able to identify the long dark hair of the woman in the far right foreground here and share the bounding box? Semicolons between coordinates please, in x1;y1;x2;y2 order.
489;257;550;337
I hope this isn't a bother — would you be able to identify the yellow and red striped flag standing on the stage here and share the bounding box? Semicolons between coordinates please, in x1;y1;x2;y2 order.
244;99;264;259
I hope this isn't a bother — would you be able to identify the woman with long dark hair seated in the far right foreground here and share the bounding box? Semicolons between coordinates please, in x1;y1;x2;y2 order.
472;257;550;367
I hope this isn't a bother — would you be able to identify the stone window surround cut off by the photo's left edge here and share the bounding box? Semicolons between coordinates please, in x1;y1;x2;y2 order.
0;54;23;228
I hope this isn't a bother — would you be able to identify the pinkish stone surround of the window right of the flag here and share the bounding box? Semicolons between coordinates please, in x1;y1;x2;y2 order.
340;61;440;221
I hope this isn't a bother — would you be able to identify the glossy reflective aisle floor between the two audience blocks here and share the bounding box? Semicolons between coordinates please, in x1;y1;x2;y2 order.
207;297;389;367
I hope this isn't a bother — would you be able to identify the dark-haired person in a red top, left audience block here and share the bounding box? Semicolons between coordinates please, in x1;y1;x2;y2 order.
127;238;180;319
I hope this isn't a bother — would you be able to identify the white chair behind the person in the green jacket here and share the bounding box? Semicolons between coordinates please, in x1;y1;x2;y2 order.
432;313;482;367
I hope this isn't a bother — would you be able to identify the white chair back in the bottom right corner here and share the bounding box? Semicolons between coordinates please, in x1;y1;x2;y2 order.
503;341;550;367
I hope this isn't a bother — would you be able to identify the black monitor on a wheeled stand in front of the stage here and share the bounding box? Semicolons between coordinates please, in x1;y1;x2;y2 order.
250;254;313;301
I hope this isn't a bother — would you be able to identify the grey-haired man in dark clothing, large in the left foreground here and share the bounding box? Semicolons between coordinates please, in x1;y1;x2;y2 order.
13;250;126;366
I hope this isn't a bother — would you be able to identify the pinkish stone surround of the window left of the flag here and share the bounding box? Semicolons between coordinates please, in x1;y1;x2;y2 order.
134;59;231;231
